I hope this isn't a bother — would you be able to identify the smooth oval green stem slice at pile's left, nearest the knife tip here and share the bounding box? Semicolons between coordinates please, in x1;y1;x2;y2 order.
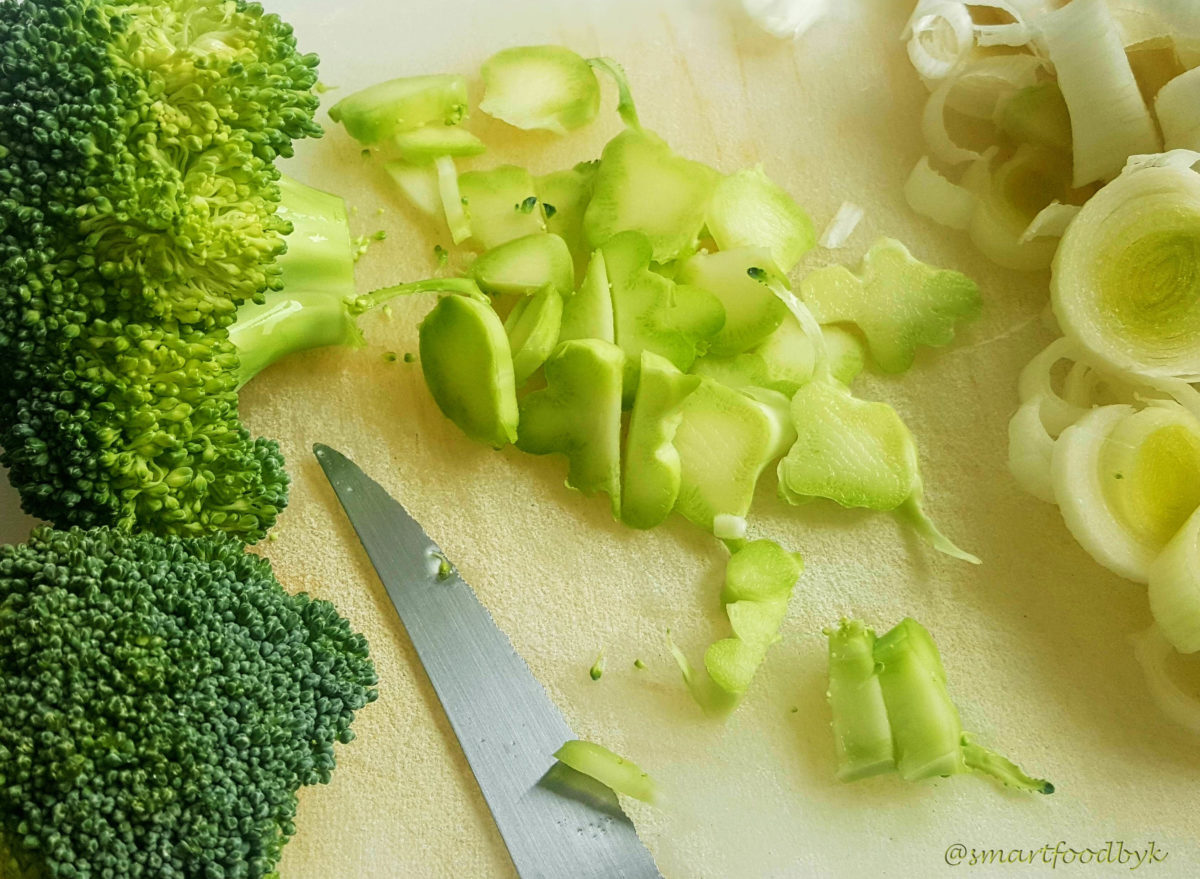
419;295;518;448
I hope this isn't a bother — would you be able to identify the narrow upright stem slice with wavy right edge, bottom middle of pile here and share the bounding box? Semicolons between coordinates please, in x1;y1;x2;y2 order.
620;351;700;528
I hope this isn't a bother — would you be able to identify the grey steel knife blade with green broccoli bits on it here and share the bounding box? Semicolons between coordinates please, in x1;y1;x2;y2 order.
313;443;661;879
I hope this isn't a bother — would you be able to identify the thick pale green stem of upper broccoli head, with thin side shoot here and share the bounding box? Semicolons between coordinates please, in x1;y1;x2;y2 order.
229;177;482;388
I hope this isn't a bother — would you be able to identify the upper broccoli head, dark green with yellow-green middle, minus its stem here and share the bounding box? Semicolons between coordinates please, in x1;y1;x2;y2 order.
0;0;324;540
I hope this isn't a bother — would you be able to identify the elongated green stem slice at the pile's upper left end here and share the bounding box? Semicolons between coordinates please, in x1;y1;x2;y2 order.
329;73;468;147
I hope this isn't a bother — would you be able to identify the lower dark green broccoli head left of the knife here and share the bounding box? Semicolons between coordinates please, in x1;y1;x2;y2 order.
0;528;377;879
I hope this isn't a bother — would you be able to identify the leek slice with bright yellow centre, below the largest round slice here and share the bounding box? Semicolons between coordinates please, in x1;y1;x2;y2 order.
1052;401;1200;582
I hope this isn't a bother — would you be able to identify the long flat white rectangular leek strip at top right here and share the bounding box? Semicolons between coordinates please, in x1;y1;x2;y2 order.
1038;0;1160;186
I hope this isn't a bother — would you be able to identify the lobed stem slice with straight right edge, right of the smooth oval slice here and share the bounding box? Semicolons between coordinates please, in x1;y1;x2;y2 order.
516;339;625;518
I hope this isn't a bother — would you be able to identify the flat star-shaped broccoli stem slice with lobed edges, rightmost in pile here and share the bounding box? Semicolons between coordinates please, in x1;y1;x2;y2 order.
800;238;980;372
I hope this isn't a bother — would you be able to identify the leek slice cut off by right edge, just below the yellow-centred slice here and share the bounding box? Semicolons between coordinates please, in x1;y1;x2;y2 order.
1148;507;1200;653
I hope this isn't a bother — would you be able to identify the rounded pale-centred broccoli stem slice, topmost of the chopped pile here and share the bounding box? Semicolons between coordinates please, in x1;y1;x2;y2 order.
479;46;600;134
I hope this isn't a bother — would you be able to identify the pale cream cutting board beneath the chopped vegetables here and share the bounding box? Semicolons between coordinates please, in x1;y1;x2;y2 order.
0;0;1200;879
